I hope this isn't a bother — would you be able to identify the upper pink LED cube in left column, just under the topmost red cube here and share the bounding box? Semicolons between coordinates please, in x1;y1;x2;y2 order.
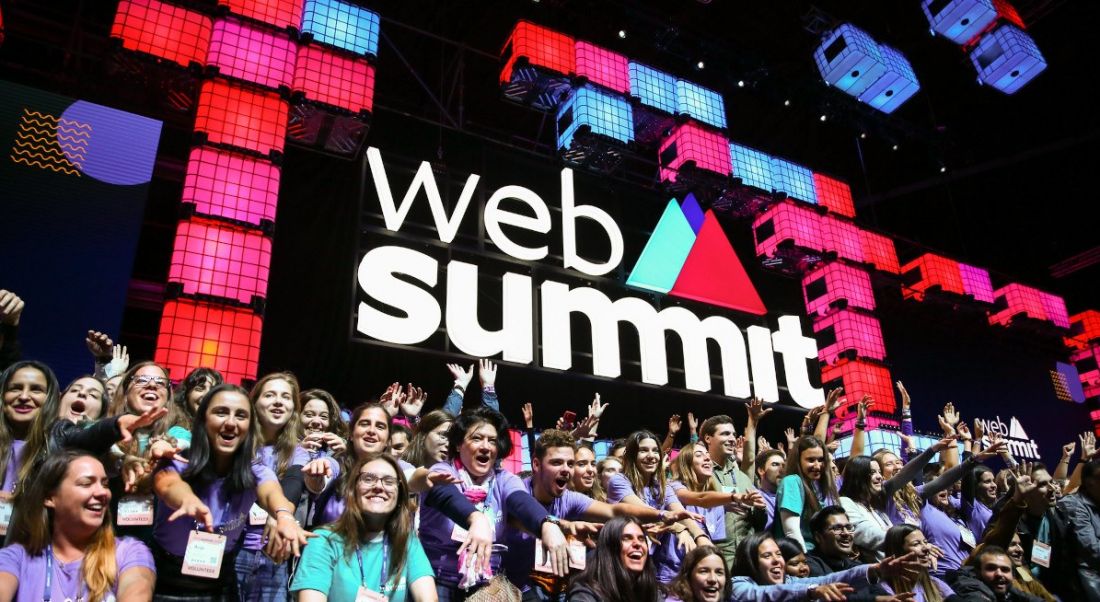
209;19;297;88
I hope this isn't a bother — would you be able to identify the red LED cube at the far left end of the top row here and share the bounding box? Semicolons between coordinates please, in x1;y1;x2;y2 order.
111;0;213;67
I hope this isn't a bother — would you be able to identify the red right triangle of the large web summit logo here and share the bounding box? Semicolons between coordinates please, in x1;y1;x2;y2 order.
669;211;768;316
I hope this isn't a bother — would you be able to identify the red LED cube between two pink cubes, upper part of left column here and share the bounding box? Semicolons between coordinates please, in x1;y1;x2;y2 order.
195;79;288;154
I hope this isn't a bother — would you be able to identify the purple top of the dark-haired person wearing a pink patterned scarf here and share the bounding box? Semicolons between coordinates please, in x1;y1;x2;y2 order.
420;462;524;584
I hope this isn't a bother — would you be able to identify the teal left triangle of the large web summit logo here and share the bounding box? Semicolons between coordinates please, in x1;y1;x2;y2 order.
626;199;695;293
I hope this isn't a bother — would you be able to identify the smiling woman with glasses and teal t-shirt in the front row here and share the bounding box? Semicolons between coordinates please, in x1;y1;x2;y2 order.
290;453;437;602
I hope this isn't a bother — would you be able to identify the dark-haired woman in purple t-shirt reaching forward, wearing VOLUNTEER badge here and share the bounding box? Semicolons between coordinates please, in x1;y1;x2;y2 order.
146;384;307;600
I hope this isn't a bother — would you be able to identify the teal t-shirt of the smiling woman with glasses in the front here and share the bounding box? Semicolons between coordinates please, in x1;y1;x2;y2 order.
290;529;435;602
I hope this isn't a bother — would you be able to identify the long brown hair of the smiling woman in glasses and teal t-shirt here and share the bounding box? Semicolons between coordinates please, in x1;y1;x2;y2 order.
331;452;413;587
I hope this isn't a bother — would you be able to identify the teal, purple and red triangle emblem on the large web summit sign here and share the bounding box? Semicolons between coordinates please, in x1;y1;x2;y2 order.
627;194;768;316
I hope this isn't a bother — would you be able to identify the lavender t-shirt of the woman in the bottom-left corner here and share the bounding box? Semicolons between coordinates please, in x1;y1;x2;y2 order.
0;537;156;602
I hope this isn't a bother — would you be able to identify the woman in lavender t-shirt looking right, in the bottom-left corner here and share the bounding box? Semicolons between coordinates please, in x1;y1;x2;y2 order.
0;451;156;602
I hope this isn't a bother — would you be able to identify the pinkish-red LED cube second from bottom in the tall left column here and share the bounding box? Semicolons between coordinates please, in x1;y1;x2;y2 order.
168;219;272;303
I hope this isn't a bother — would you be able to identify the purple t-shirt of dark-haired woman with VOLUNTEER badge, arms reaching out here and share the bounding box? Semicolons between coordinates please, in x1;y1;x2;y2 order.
153;460;278;557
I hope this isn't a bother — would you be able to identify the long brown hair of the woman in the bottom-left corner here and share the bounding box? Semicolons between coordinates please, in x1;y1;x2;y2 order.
8;450;119;602
